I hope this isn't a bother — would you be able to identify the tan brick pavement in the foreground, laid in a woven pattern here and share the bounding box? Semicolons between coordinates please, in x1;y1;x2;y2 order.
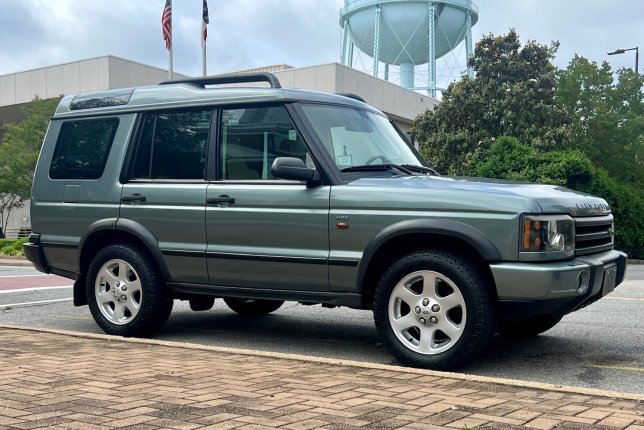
0;326;644;430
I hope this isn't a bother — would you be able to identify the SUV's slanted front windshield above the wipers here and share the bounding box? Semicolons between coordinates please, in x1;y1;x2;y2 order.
302;105;422;172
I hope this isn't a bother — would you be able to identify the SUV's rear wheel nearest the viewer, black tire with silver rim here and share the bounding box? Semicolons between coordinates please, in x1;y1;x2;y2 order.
86;244;173;337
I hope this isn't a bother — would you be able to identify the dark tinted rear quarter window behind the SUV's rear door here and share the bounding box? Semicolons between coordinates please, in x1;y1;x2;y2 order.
49;118;119;179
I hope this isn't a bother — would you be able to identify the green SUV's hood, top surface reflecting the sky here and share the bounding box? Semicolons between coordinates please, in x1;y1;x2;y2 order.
348;175;611;217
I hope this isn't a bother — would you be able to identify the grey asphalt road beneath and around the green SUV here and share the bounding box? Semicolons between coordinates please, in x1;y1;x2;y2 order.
0;266;644;394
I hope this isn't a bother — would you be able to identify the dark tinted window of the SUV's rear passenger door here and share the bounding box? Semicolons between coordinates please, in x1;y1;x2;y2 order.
132;110;212;179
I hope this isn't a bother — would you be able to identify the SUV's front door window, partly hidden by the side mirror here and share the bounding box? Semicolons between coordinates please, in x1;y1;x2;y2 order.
219;106;310;180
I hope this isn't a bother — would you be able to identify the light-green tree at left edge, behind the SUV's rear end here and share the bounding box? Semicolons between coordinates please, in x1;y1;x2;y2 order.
0;97;60;231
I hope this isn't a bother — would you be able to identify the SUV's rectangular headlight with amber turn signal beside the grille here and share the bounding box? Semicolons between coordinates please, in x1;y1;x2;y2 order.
519;215;575;261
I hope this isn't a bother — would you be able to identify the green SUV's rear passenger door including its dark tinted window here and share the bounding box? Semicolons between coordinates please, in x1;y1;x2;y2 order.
120;108;213;284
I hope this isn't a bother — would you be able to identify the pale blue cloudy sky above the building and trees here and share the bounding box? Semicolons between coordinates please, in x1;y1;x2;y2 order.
0;0;644;90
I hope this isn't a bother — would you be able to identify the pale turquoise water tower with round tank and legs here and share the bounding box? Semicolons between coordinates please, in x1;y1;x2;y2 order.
340;0;478;98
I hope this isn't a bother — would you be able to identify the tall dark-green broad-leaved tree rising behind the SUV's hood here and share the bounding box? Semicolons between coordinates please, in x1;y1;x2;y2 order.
412;30;570;174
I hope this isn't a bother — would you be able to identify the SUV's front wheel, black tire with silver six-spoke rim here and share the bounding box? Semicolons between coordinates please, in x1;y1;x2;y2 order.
373;251;496;370
